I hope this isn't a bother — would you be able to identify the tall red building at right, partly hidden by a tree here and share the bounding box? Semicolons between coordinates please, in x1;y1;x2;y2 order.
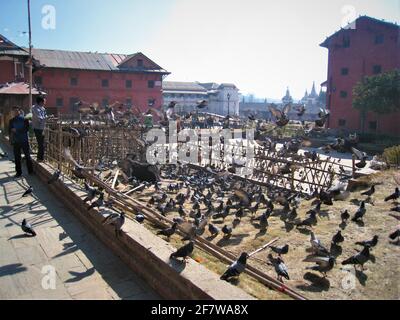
321;16;400;136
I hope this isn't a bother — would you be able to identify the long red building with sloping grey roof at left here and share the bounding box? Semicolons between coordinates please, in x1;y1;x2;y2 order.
0;35;169;113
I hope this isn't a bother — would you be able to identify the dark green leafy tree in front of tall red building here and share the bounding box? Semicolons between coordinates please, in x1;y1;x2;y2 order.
353;70;400;131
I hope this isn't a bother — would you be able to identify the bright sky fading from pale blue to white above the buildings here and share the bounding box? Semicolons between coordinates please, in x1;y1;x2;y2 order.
0;0;400;99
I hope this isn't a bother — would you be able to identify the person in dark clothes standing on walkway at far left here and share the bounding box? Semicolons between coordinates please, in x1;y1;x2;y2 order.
8;107;33;178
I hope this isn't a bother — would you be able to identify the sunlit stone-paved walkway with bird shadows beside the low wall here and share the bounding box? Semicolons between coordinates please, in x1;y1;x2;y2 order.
0;145;159;300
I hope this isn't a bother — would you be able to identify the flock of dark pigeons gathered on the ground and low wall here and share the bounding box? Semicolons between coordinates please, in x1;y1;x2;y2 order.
15;144;400;294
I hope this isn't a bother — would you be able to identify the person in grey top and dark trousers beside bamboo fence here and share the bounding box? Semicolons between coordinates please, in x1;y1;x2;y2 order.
32;97;47;162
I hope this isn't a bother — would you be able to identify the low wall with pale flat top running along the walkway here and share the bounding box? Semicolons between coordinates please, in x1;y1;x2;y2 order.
34;163;254;300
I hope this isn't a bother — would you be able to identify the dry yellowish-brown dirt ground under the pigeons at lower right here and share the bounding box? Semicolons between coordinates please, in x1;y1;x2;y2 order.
123;170;400;300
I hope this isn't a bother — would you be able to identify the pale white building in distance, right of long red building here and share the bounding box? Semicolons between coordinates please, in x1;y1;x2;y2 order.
163;81;240;116
